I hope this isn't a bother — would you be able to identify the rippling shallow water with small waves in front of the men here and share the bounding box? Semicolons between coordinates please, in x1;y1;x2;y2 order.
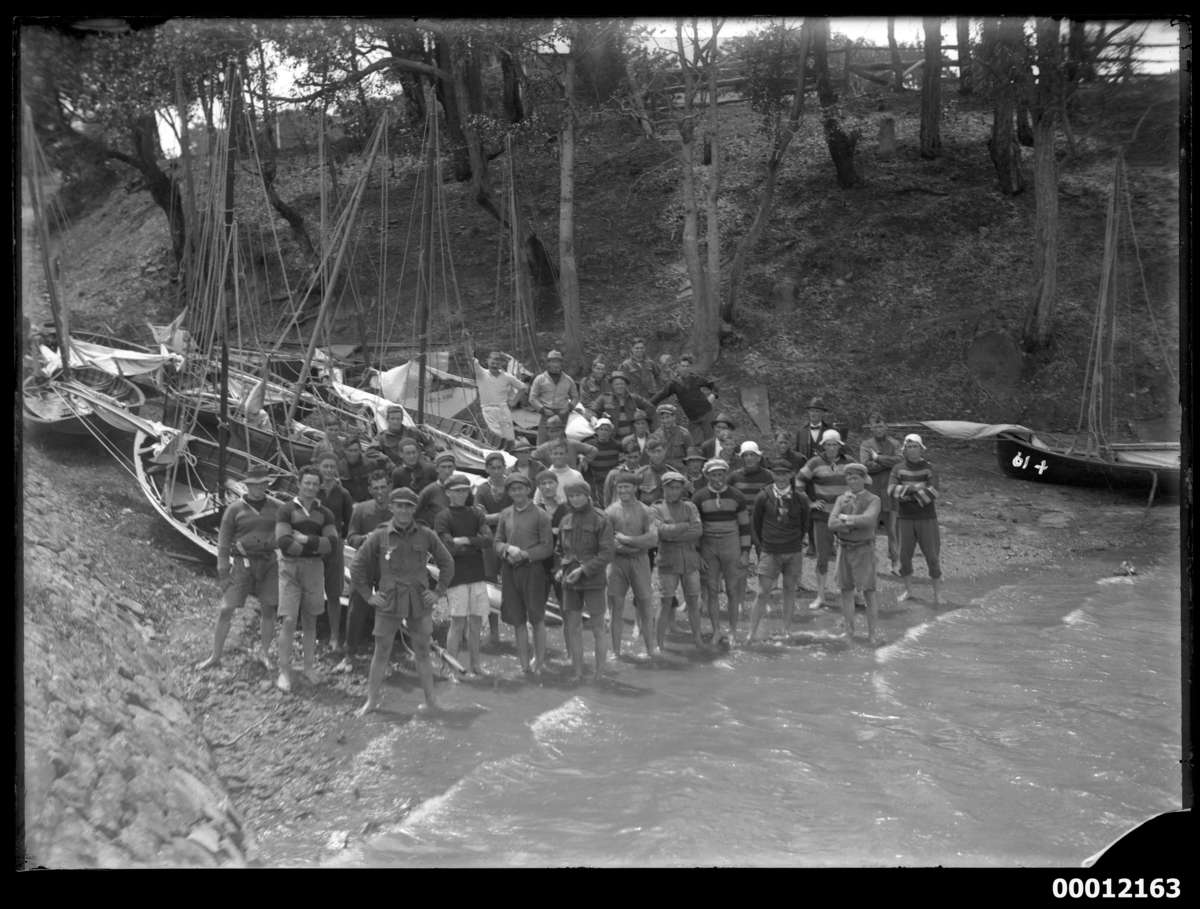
324;564;1181;867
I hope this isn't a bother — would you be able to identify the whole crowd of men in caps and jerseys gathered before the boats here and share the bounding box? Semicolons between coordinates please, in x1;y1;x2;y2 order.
202;339;941;712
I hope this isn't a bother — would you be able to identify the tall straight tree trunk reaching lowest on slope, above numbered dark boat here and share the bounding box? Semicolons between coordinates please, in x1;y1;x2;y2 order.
1024;17;1062;349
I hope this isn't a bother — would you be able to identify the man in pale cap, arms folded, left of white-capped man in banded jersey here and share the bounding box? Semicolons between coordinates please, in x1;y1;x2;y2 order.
650;470;705;650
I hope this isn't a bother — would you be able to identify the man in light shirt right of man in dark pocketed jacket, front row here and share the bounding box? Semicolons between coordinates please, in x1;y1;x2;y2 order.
604;470;659;658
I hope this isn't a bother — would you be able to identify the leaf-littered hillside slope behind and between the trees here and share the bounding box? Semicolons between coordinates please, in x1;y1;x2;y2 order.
34;72;1178;435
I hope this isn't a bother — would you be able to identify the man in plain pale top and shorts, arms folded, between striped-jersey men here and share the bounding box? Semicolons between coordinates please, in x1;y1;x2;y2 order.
829;460;880;644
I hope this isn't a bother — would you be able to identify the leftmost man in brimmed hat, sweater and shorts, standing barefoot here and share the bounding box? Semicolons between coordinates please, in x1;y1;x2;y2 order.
196;466;280;670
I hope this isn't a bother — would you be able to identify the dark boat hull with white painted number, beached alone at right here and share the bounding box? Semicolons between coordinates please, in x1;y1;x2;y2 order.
996;433;1180;495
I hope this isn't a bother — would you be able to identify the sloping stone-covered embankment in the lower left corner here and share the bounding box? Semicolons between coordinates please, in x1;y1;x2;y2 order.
24;477;254;868
